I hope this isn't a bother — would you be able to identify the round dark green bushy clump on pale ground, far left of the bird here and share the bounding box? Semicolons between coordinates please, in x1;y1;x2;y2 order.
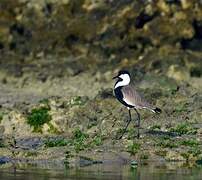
27;107;51;132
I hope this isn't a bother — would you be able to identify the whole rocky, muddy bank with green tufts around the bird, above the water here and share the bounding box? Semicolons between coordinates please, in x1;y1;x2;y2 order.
0;0;202;166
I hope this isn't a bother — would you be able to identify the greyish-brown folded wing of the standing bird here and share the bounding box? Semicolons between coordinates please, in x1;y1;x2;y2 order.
122;85;152;109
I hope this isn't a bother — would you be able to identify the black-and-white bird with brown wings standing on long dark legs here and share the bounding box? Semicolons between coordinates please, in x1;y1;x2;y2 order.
113;70;161;139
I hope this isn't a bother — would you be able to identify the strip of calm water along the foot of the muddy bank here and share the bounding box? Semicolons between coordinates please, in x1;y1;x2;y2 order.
0;163;202;180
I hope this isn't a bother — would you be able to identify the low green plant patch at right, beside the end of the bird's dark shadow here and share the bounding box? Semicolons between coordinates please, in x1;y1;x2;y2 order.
169;123;197;135
